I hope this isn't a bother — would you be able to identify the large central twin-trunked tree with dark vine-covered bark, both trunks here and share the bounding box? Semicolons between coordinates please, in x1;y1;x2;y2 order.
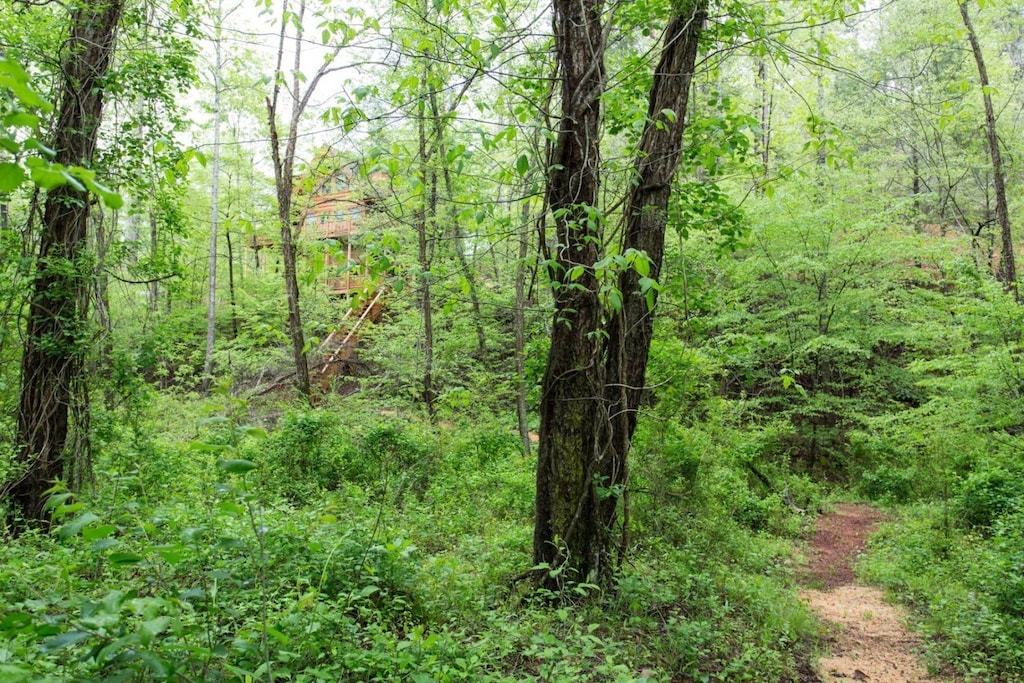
534;0;708;586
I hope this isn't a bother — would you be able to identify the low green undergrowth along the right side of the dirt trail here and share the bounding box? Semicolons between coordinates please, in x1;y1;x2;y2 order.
860;499;1024;683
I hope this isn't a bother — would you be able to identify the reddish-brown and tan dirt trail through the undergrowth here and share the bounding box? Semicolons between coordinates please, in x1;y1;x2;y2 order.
801;504;948;683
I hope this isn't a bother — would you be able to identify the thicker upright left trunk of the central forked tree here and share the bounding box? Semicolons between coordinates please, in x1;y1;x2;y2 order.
534;0;610;588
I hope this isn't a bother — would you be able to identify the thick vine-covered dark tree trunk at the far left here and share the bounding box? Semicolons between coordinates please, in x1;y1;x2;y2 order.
3;0;123;521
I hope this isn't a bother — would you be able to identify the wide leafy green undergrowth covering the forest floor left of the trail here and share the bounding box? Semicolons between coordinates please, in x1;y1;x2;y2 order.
0;394;816;683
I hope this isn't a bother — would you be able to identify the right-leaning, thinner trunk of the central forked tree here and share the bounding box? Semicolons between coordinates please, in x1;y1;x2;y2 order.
601;0;708;565
